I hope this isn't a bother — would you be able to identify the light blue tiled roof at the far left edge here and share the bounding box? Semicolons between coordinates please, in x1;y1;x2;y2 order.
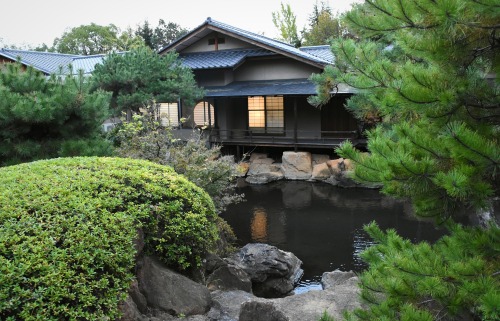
0;48;81;74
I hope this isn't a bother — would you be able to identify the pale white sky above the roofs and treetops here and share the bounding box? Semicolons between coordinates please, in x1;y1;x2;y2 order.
0;0;361;47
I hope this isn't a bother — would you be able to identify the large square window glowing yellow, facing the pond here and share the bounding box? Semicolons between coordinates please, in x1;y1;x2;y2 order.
248;96;284;133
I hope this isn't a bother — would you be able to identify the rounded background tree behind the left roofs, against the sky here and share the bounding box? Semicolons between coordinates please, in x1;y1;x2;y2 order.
53;23;143;55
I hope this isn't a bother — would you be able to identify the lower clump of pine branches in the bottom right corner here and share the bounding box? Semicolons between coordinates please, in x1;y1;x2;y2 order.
347;223;500;321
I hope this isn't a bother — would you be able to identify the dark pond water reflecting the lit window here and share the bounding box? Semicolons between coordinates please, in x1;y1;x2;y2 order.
222;181;443;293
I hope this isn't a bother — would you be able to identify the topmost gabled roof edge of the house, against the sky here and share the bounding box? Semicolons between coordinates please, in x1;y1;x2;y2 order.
159;18;332;66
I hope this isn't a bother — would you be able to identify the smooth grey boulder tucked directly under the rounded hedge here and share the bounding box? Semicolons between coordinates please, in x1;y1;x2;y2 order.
137;256;212;316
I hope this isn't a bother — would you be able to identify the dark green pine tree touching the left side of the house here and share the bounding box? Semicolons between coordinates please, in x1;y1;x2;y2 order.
92;47;203;115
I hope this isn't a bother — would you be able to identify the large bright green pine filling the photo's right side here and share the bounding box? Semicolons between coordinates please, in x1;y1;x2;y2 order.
311;0;500;320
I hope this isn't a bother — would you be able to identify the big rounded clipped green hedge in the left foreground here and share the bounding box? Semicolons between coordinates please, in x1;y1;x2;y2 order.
0;157;217;320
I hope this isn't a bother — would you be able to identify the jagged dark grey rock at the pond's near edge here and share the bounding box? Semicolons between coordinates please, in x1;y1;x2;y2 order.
226;243;303;297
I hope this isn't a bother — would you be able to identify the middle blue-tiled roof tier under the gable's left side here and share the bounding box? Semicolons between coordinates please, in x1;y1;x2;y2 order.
179;49;275;69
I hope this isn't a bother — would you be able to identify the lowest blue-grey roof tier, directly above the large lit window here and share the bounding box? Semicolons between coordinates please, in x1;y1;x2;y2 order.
205;79;316;97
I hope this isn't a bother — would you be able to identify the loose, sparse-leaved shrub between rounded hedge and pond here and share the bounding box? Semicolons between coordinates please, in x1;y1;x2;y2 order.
116;106;243;212
